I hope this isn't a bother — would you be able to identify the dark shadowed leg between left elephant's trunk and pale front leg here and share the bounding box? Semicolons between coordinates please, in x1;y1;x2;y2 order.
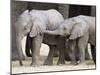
25;35;32;57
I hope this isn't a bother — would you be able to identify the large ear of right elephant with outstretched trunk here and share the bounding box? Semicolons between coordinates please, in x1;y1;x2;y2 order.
69;20;88;40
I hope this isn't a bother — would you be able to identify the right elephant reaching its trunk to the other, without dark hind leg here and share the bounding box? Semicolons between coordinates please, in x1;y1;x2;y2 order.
44;15;96;64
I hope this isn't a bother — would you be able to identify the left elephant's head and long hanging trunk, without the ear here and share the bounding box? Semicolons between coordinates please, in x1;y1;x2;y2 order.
15;10;32;65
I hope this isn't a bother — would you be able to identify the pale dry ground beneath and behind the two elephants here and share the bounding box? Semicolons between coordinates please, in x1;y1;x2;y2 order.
12;36;95;74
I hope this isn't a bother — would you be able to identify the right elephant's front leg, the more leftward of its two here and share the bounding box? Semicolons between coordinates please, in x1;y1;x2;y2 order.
68;40;77;65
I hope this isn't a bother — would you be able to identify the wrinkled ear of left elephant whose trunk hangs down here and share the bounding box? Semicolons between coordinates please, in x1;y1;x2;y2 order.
29;19;46;37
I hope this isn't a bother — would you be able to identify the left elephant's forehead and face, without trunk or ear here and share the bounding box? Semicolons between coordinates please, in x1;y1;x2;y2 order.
15;10;32;36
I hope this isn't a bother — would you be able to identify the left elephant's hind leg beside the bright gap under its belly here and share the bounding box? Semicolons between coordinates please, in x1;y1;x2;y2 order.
44;45;55;65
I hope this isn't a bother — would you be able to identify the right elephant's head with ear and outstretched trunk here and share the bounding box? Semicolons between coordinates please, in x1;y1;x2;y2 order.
44;16;89;40
